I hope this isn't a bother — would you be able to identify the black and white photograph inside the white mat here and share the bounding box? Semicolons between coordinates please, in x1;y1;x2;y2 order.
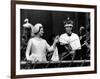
20;9;91;69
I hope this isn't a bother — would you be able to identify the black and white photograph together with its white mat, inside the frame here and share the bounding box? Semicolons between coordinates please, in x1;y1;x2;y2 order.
11;2;96;77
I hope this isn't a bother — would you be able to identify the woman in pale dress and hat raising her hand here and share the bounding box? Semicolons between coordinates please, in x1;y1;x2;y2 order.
26;23;58;62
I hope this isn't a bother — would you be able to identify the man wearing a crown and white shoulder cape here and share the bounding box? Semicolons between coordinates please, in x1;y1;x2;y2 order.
59;18;81;59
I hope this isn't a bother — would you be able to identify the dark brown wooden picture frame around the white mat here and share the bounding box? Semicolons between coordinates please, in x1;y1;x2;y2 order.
11;0;97;79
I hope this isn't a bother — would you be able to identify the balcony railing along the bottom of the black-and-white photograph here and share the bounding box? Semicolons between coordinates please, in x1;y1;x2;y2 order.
20;60;90;69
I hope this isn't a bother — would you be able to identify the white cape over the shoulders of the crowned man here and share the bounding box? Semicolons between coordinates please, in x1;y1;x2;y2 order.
59;33;81;50
